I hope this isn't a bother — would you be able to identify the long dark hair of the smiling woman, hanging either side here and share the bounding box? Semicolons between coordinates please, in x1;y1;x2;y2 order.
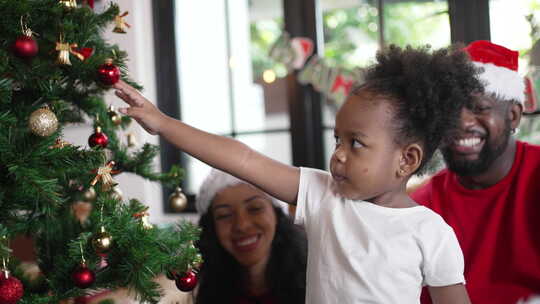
195;206;307;304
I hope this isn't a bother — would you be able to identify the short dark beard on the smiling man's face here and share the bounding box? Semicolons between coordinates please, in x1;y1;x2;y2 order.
441;119;512;176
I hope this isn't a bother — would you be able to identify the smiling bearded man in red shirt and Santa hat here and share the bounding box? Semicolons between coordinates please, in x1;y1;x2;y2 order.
412;41;540;304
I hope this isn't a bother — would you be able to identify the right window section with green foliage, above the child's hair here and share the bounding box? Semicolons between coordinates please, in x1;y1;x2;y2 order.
321;0;450;164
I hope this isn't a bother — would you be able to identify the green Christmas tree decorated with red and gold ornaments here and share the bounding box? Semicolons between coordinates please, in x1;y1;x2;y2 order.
0;0;202;304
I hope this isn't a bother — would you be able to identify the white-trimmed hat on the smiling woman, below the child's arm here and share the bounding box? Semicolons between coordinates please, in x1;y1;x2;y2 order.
195;168;279;215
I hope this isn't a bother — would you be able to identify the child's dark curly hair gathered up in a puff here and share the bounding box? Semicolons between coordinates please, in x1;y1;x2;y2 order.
352;45;484;174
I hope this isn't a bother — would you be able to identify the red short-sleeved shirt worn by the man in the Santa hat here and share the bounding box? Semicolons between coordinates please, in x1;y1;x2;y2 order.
412;142;540;304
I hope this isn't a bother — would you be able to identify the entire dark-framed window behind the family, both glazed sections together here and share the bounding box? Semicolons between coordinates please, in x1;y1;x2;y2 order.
153;0;508;214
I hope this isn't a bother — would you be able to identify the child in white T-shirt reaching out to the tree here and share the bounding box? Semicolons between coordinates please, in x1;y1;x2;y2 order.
115;46;482;304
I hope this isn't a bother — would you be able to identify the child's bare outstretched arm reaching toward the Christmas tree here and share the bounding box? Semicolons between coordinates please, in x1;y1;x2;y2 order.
114;80;300;204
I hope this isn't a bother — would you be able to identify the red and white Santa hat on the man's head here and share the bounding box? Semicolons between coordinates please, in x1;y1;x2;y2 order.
464;40;525;104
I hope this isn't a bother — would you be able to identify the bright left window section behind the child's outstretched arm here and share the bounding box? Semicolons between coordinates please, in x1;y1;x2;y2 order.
175;1;291;193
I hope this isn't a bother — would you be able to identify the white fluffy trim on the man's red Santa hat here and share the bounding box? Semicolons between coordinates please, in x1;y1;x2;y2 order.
473;61;525;104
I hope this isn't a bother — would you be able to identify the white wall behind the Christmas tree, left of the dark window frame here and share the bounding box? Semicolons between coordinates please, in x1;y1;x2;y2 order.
64;0;197;223
